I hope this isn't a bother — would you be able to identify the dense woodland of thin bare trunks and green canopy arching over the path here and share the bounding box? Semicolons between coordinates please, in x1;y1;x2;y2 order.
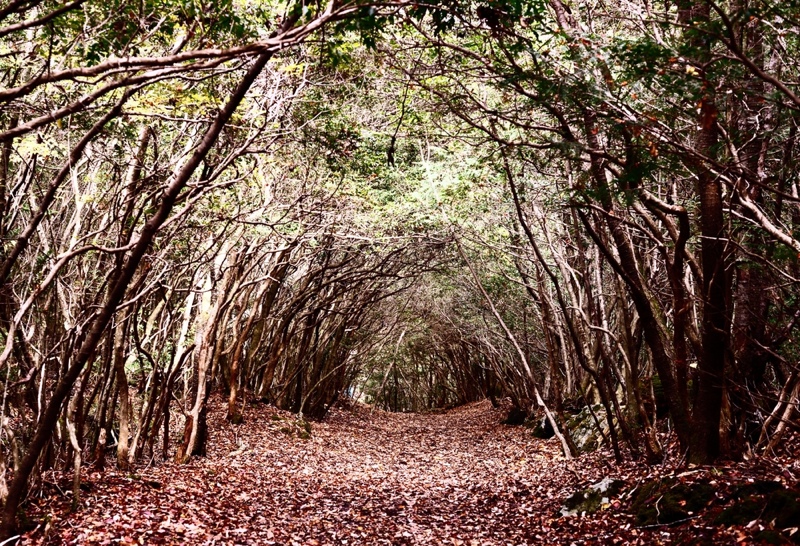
0;0;800;537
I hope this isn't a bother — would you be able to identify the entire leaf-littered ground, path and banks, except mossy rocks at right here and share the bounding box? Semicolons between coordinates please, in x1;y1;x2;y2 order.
14;401;800;546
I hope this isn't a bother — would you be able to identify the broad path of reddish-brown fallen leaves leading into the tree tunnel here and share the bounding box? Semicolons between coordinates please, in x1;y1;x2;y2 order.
25;402;616;545
